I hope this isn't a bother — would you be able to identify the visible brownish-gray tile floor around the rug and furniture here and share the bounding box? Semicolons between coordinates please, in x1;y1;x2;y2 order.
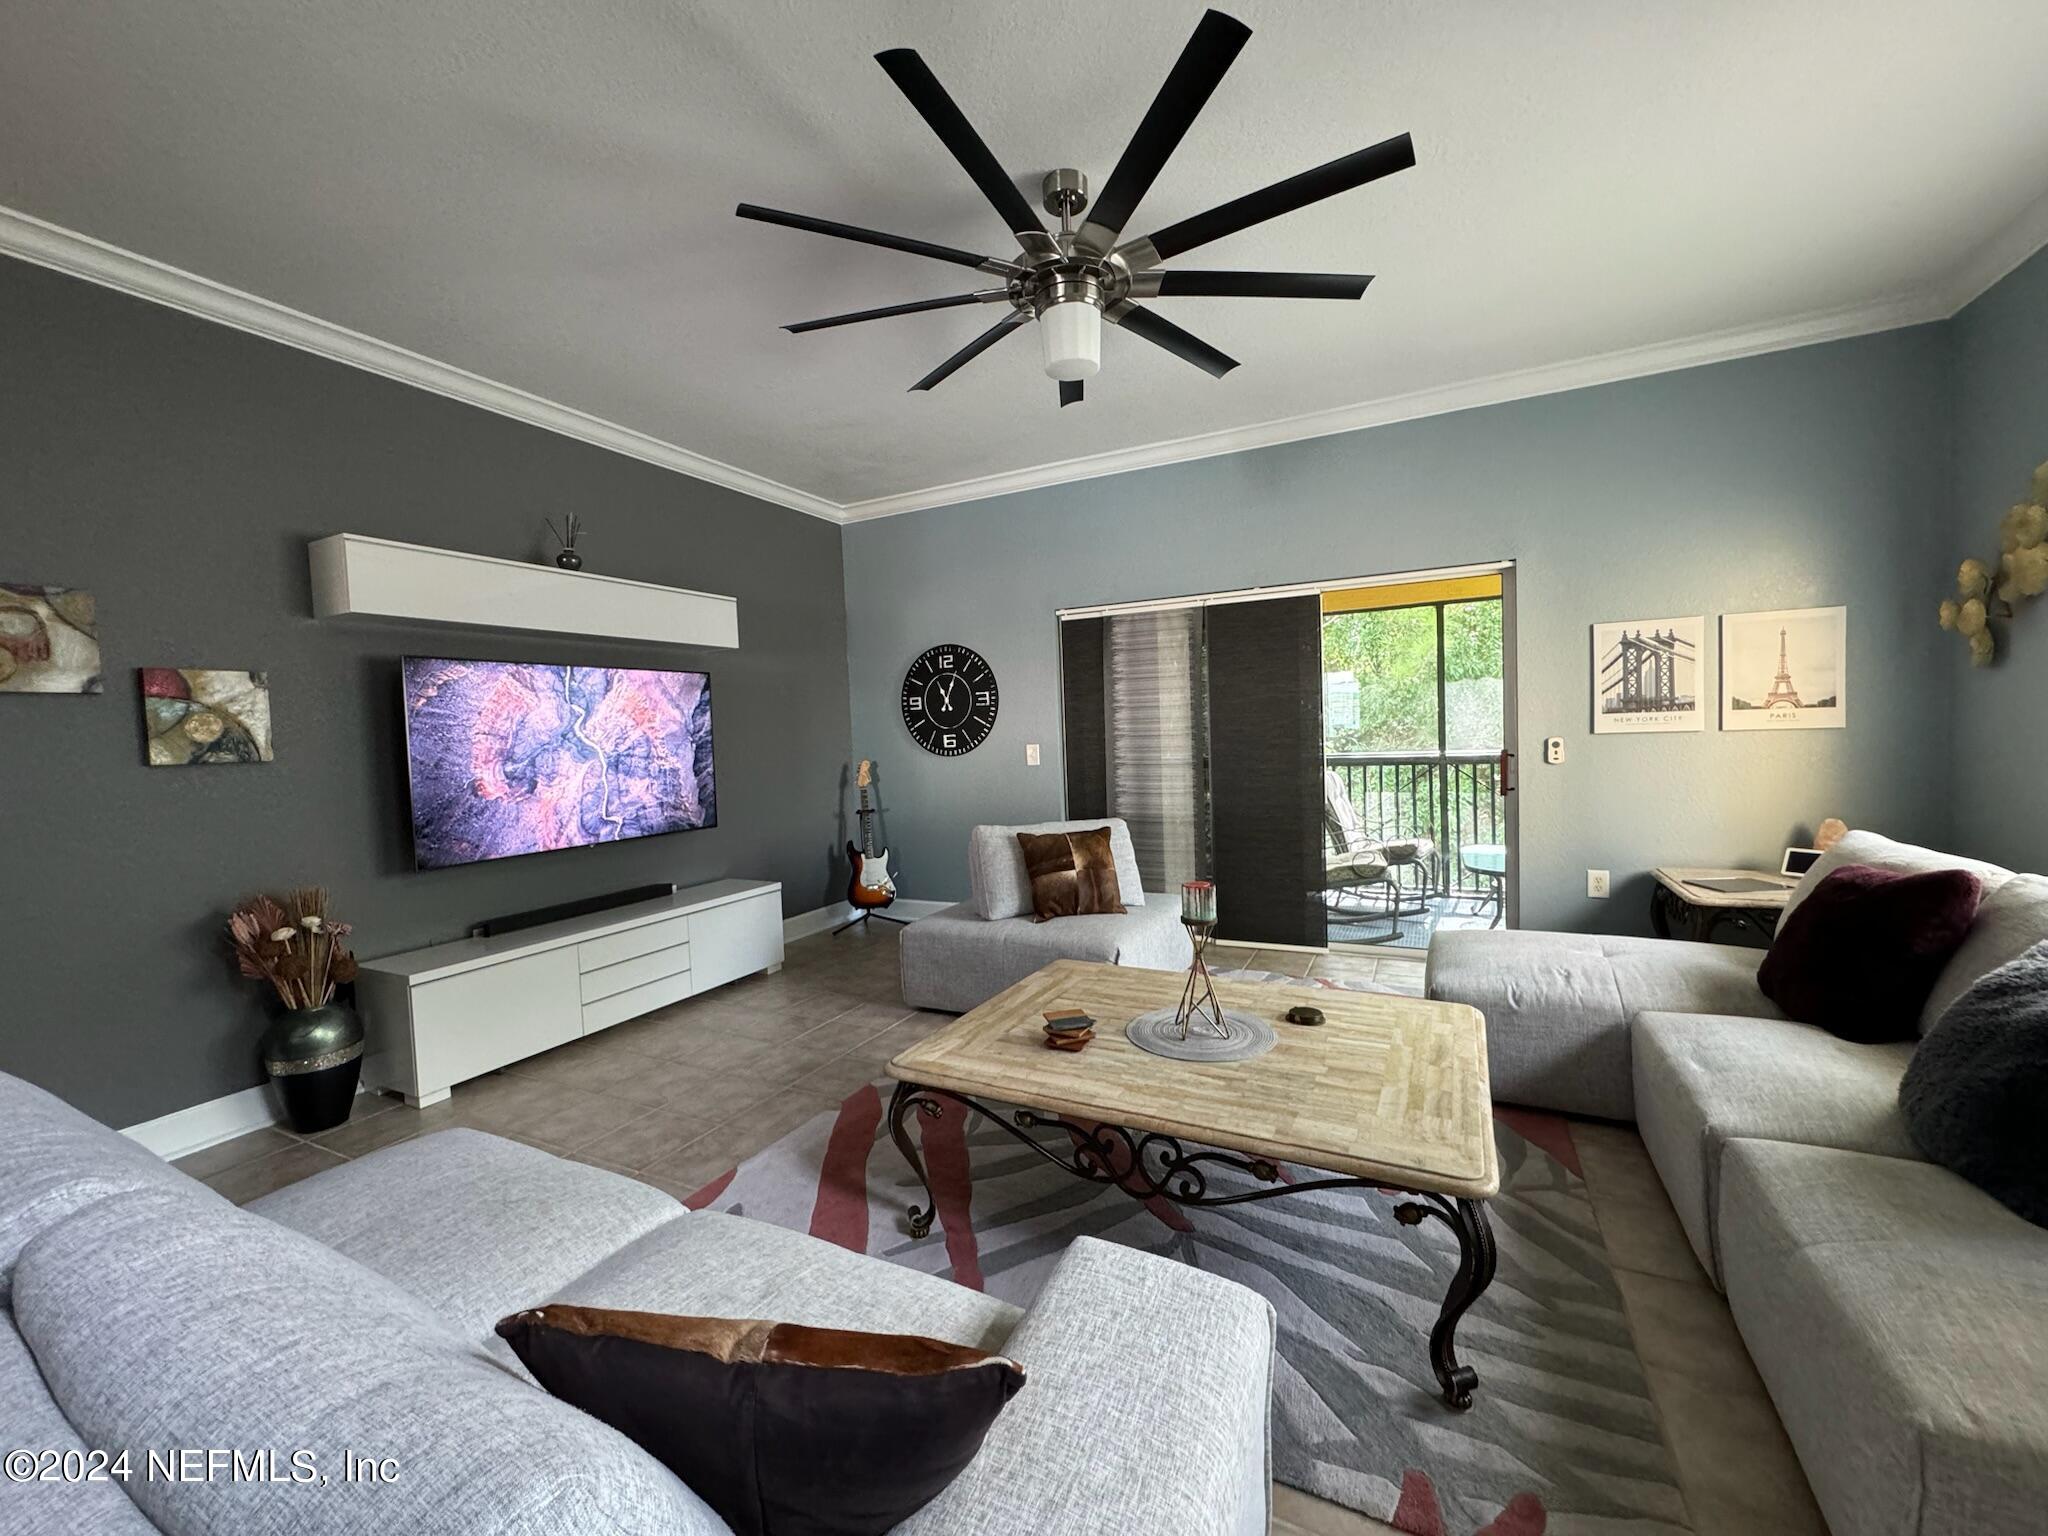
178;928;1827;1536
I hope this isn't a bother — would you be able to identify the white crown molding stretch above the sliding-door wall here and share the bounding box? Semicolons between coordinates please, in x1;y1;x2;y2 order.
844;293;1948;522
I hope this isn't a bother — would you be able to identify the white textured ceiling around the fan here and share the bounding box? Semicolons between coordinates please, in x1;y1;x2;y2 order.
0;0;2048;512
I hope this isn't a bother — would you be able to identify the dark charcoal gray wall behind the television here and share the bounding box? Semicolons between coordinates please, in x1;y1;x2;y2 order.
0;260;848;1124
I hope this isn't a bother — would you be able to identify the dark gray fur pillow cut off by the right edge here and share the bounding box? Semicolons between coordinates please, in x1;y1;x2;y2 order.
1898;940;2048;1227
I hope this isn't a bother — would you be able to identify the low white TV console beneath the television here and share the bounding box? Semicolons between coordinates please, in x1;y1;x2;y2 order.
356;881;782;1108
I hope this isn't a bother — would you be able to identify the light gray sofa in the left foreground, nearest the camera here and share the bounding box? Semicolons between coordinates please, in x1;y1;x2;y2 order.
0;1075;1274;1536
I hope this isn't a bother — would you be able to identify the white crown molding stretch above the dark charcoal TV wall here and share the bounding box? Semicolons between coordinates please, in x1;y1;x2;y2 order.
0;207;840;522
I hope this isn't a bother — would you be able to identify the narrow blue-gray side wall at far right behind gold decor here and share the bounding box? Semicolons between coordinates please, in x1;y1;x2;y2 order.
1923;252;2048;870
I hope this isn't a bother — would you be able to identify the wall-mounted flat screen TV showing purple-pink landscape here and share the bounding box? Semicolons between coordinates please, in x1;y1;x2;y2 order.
403;655;719;868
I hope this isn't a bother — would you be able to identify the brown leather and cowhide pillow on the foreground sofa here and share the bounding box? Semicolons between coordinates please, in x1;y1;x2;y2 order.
498;1307;1024;1536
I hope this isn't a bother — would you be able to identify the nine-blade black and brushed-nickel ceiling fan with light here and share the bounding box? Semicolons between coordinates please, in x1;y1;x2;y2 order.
737;10;1415;406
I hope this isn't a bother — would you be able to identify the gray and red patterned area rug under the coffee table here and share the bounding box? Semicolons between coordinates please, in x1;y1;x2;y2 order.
690;1085;1690;1536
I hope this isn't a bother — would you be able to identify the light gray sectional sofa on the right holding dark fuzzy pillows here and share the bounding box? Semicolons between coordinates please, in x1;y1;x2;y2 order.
1427;831;2048;1536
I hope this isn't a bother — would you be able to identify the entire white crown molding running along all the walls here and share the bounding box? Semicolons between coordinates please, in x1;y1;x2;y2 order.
0;197;2048;528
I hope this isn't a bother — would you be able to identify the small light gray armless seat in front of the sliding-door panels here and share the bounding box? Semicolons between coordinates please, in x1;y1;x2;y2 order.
899;817;1194;1014
